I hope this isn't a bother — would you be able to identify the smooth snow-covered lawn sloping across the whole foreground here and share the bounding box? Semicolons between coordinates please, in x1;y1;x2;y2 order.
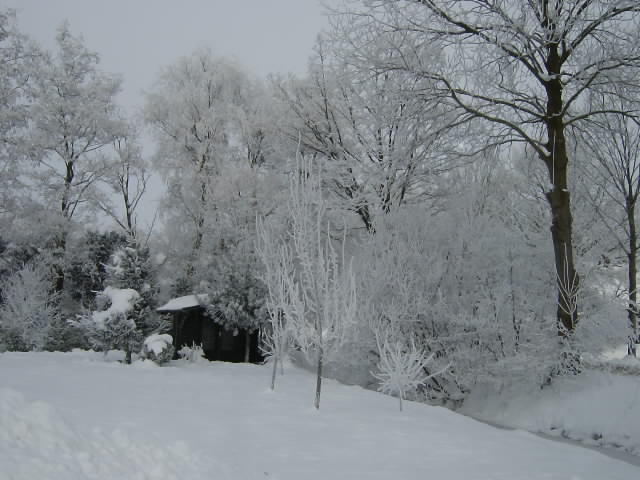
0;353;640;480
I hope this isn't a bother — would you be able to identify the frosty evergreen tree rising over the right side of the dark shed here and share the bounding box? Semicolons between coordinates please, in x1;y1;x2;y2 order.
194;162;282;360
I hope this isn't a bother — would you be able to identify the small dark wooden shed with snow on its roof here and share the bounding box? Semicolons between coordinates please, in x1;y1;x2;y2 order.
157;294;263;363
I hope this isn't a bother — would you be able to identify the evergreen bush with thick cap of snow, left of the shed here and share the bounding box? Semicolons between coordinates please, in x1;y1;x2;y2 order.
72;287;144;363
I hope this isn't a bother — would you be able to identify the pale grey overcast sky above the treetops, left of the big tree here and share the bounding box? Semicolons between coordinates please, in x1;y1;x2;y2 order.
8;0;336;106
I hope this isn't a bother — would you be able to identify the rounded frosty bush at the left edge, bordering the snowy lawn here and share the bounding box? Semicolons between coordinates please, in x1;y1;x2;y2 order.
0;263;60;351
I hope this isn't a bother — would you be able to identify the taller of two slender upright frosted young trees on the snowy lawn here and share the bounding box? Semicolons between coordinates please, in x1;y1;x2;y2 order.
262;162;357;408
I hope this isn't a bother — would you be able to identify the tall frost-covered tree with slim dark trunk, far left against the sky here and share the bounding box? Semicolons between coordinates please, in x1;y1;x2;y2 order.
23;23;122;291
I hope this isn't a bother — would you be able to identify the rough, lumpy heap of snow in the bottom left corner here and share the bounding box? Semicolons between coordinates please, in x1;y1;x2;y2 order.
0;389;203;480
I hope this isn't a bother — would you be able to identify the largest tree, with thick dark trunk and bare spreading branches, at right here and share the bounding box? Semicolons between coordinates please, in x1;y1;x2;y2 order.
336;0;640;332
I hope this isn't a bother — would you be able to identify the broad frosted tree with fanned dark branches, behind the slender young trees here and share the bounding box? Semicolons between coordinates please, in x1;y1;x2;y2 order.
276;32;469;231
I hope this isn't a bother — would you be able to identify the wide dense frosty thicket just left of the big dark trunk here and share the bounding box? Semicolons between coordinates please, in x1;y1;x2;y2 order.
356;185;560;403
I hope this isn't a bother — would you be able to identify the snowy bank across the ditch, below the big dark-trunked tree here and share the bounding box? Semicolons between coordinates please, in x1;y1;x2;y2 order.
462;370;640;455
